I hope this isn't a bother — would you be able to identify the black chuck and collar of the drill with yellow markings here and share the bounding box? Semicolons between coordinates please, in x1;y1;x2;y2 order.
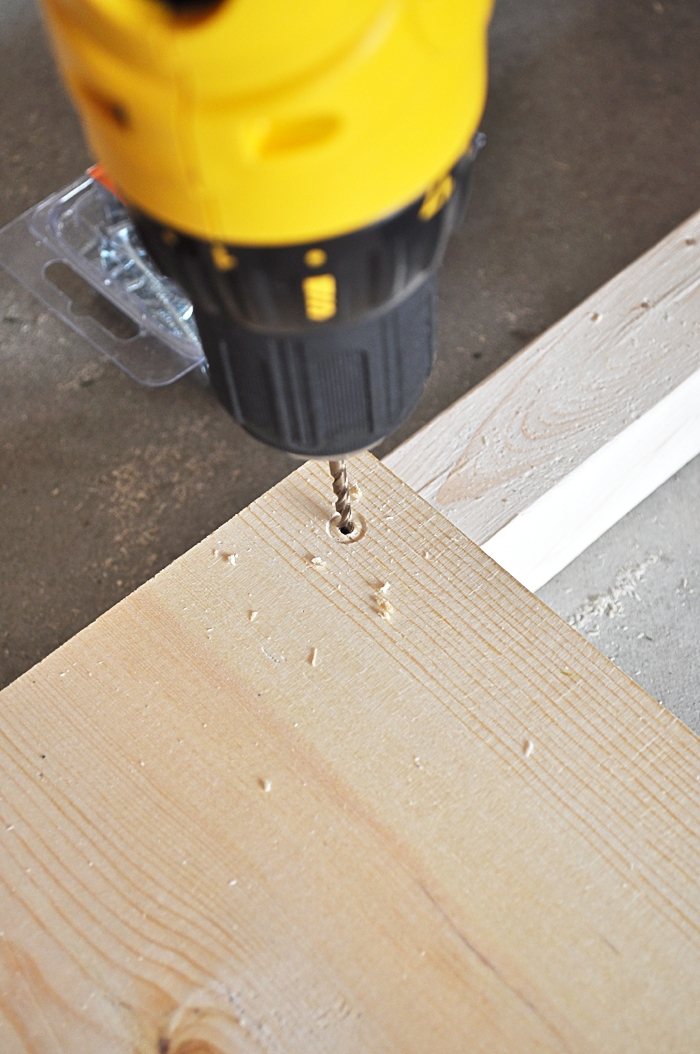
134;136;482;457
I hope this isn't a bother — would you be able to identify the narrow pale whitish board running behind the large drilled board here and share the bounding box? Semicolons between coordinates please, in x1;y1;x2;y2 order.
386;213;700;589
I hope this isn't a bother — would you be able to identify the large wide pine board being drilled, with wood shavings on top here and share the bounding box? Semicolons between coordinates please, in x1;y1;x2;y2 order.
0;455;700;1054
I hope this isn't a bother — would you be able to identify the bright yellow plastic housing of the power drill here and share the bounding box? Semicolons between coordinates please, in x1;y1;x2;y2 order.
44;0;492;246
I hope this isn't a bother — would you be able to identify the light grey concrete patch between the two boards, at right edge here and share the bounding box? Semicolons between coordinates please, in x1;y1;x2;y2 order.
538;457;700;735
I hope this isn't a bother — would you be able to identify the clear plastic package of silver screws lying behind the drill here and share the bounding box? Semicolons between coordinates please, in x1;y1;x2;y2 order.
0;167;205;387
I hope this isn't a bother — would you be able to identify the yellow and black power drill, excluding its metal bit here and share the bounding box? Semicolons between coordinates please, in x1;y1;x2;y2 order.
36;0;492;457
